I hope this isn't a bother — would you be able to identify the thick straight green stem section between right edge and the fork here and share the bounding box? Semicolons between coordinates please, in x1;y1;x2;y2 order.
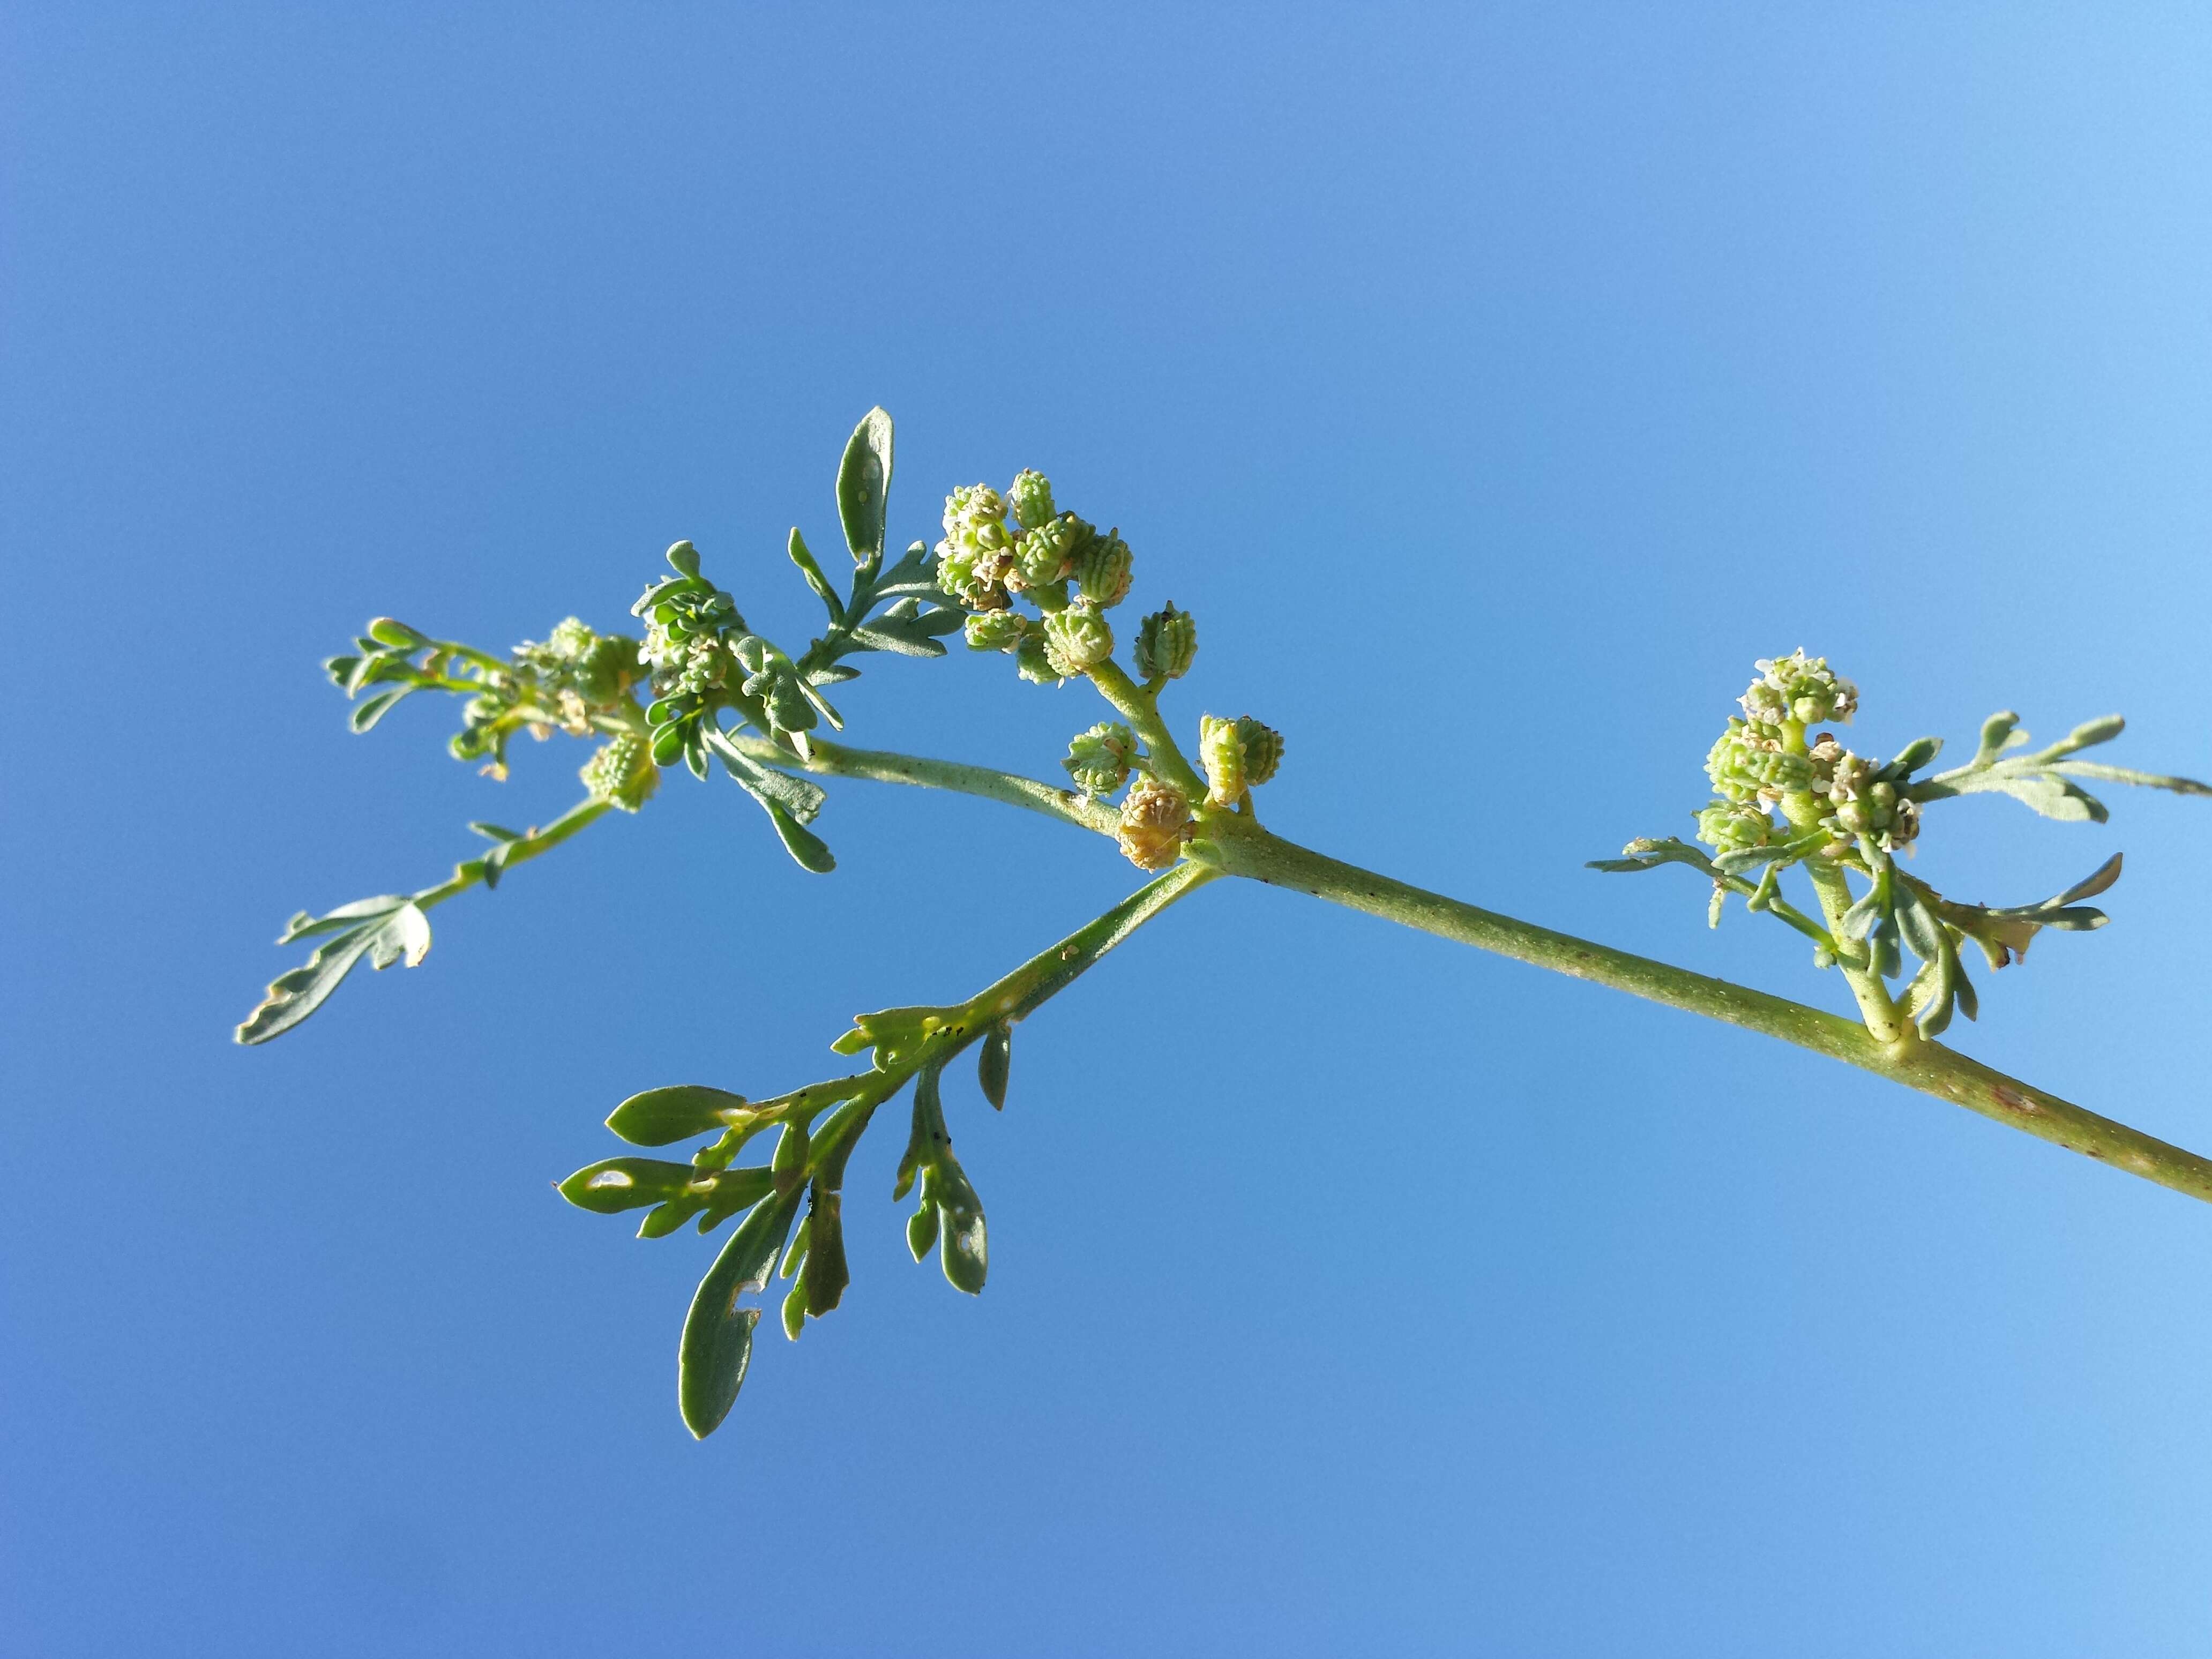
1212;832;2212;1201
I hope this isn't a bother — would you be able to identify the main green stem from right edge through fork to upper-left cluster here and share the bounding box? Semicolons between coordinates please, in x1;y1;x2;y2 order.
756;739;2212;1201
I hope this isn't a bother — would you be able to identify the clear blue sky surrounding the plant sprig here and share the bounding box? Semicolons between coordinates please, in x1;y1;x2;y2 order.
0;4;2212;1659
